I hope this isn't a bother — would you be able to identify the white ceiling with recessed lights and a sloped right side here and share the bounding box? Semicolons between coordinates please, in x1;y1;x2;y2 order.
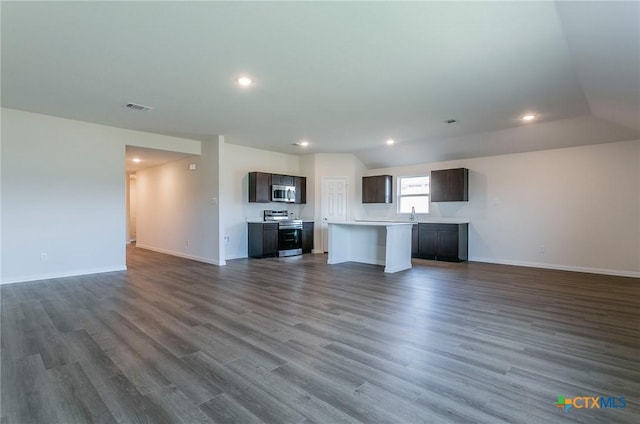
1;1;640;168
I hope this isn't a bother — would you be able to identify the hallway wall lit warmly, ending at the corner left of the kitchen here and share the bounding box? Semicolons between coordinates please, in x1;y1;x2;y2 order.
136;139;224;265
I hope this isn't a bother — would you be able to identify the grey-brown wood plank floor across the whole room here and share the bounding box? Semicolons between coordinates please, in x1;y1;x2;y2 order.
0;247;640;424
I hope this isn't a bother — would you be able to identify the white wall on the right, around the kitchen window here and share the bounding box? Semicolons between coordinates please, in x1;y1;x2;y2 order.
360;141;640;277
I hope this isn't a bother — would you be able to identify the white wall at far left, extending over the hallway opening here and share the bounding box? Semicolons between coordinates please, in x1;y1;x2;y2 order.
1;108;200;283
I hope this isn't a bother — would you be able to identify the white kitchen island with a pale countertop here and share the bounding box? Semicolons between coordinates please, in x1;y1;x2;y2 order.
327;221;413;273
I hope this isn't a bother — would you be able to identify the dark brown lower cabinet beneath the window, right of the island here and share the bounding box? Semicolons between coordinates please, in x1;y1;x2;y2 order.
411;223;469;262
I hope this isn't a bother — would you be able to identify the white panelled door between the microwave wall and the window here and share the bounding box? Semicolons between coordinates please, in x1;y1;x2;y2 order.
320;177;347;252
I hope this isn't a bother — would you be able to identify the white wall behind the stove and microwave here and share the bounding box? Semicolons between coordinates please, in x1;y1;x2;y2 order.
222;144;302;259
